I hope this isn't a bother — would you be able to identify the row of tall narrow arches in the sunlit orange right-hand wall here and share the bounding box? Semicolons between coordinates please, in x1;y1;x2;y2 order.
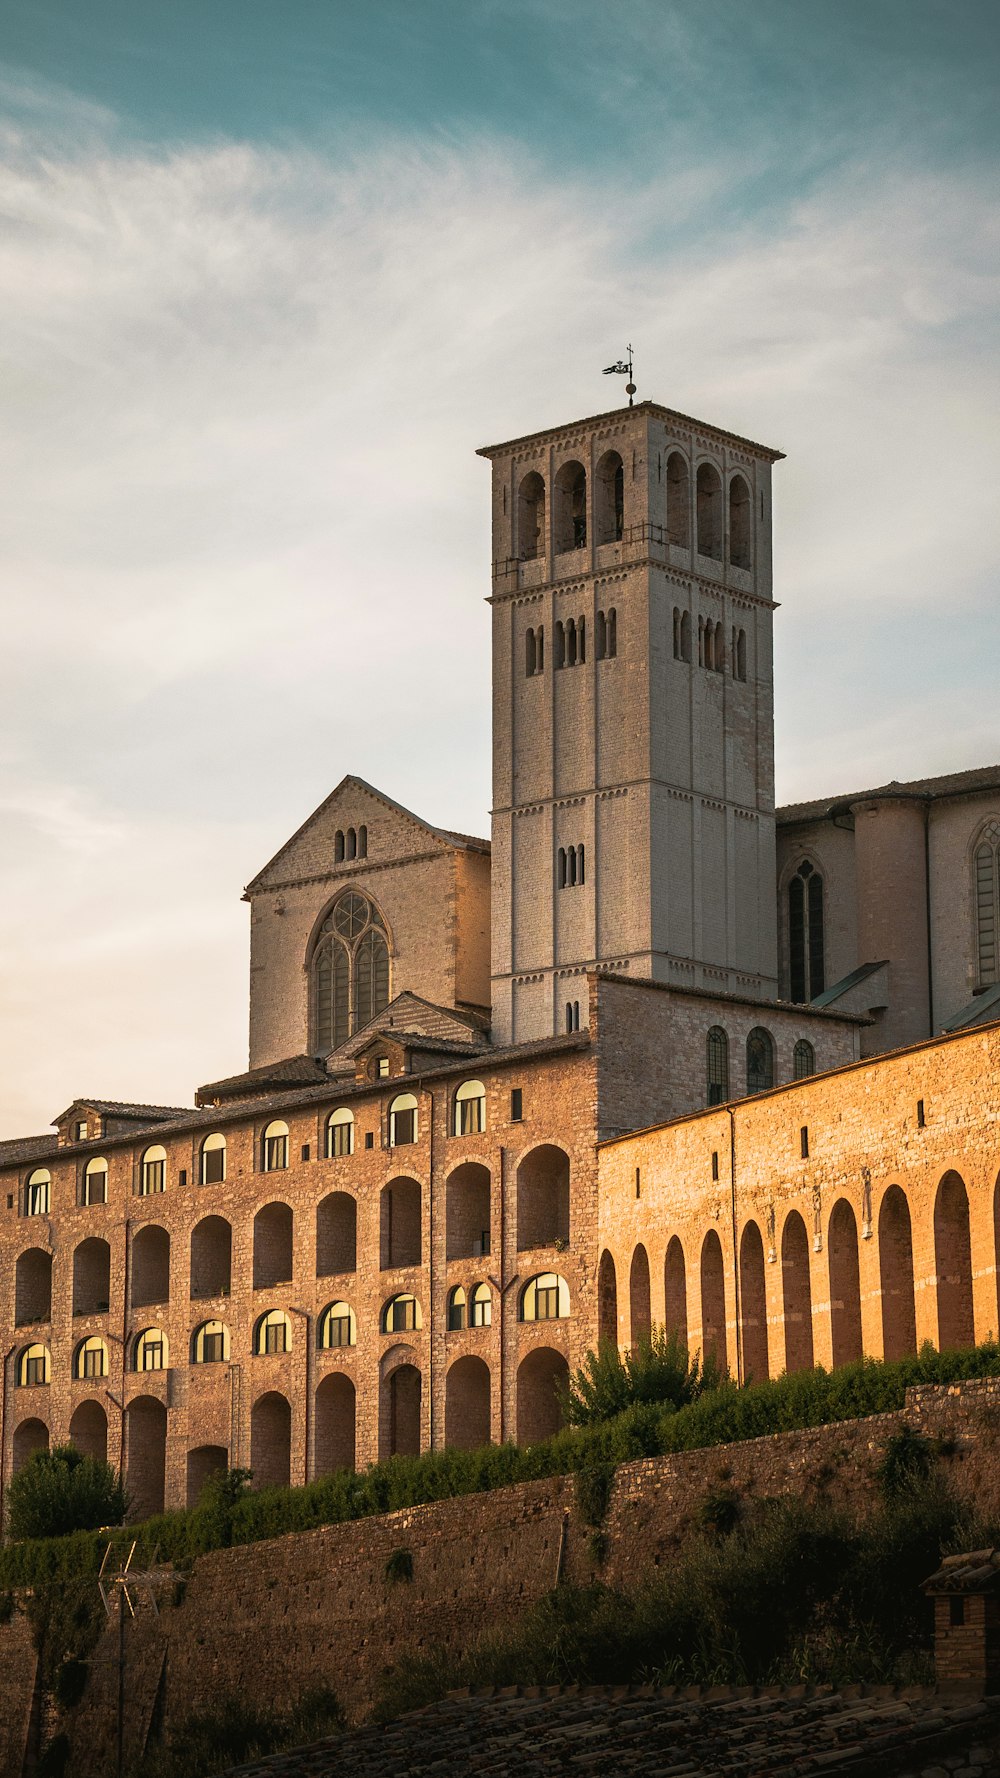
598;1170;982;1380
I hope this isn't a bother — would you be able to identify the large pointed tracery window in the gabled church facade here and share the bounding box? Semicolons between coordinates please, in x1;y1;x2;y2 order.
313;889;390;1051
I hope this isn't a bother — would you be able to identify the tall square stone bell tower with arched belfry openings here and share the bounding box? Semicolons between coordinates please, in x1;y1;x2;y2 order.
479;402;781;1042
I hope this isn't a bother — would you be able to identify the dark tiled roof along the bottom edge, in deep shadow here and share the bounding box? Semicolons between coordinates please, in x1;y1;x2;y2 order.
217;1686;1000;1778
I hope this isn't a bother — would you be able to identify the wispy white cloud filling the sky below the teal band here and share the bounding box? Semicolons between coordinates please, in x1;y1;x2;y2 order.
0;80;1000;1131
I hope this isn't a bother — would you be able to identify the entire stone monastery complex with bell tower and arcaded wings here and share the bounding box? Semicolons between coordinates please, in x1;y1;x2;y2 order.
0;402;1000;1515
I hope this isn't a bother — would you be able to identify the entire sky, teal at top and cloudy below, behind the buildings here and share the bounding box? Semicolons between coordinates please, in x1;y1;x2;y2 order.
0;0;1000;1136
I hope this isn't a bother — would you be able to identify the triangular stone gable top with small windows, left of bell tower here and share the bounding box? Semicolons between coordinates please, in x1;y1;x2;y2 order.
246;777;454;898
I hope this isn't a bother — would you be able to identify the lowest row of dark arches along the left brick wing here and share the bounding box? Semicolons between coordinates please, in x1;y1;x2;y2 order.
12;1346;569;1520
